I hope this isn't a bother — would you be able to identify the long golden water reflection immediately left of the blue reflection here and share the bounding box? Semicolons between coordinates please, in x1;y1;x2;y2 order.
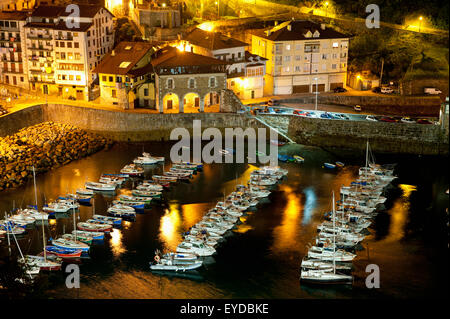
272;185;303;252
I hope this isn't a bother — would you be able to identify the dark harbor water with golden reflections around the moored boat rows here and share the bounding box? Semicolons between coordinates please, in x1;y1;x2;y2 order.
0;143;449;298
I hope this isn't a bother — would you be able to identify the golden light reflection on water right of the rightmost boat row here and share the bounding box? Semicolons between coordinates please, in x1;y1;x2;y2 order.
385;184;417;241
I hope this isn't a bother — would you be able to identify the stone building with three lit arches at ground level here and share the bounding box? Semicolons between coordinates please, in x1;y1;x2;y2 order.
152;47;228;113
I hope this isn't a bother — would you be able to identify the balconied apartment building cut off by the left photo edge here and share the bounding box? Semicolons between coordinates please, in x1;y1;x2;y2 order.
0;11;29;89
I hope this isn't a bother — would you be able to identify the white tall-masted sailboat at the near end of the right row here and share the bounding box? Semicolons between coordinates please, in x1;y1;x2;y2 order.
300;192;353;284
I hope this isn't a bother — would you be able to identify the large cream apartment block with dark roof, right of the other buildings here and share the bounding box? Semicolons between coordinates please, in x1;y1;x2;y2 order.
252;20;349;95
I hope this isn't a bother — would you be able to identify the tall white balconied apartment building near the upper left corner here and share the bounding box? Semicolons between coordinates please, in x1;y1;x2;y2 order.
24;4;114;100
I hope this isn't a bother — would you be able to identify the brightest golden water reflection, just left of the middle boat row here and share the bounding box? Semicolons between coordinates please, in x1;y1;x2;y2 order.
159;203;182;250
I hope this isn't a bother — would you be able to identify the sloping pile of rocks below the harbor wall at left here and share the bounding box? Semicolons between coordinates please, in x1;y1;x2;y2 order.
0;122;112;191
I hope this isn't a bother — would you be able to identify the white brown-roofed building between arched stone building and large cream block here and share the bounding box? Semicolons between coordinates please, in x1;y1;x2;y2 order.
181;28;267;99
